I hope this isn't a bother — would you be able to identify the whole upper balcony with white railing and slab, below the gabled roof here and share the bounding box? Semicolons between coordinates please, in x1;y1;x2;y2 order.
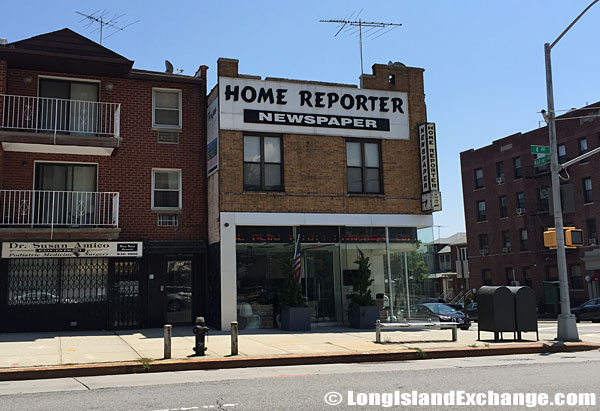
0;94;121;155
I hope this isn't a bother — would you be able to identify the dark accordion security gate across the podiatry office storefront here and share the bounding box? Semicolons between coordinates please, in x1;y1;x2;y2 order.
0;257;140;331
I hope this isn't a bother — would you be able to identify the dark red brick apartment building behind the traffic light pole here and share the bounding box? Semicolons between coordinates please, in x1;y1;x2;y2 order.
460;103;600;311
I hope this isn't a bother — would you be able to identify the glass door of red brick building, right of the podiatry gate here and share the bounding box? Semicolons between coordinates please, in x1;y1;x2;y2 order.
165;260;192;324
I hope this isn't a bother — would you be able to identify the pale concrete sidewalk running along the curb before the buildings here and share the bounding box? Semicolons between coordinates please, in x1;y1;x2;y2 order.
0;321;600;380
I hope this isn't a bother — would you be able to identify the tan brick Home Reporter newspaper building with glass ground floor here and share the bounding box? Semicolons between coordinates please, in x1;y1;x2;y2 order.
207;59;439;329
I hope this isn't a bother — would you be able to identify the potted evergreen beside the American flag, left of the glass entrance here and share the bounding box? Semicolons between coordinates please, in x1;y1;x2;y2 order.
278;257;310;331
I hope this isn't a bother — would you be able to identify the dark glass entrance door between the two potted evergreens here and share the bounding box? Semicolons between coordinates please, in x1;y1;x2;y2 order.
303;244;343;323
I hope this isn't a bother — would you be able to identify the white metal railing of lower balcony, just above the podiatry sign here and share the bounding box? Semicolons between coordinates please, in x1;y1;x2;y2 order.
0;190;119;228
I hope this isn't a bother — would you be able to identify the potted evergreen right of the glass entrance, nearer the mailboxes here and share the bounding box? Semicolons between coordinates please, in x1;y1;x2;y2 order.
350;248;379;329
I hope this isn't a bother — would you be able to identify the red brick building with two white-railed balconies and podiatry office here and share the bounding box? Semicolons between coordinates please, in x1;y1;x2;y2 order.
0;29;207;331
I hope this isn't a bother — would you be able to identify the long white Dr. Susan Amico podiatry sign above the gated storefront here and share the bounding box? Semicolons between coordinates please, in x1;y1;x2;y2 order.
2;241;142;258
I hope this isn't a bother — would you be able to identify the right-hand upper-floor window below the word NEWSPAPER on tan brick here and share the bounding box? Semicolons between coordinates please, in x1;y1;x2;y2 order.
346;141;382;194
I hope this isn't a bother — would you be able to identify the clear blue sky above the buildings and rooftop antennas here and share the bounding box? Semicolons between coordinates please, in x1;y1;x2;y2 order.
0;0;600;238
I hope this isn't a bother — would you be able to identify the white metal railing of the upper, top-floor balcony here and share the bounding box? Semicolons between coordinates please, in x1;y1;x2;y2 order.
0;94;121;138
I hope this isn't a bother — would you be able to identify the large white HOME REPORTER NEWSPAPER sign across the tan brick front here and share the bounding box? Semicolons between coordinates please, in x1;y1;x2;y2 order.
219;77;409;140
